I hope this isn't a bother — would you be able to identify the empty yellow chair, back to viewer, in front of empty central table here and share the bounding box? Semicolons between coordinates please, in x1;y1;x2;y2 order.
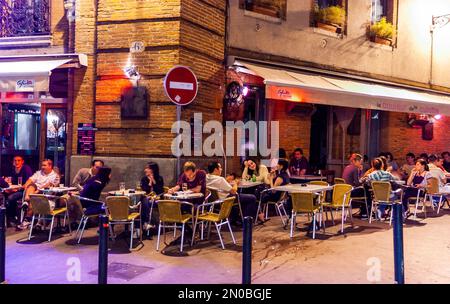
289;192;325;239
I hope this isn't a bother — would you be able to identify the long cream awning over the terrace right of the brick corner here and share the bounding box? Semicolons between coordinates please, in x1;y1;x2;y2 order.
234;60;450;115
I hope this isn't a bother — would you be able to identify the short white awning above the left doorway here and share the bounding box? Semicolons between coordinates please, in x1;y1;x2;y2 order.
0;54;87;92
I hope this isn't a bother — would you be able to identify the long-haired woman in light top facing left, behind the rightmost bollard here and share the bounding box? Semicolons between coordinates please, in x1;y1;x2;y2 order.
402;159;432;218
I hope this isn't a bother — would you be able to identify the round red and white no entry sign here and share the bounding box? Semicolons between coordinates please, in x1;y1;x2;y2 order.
164;66;198;106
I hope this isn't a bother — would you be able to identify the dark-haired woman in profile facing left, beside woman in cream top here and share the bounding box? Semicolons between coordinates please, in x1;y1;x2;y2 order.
258;159;289;222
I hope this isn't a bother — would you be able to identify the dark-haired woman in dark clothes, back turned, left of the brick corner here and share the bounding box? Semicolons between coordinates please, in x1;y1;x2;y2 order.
80;167;111;215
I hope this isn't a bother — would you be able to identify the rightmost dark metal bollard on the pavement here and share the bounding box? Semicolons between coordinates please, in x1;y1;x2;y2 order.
393;203;405;284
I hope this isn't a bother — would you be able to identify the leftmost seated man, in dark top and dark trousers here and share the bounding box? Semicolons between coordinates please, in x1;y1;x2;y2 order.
6;155;33;224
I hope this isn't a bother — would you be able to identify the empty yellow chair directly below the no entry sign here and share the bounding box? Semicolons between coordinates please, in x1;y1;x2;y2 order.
156;200;194;252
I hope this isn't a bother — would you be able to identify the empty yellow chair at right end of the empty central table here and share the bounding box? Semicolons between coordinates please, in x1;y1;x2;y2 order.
322;184;353;233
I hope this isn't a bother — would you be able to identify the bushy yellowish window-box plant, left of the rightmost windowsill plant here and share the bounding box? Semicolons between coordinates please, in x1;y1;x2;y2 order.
314;5;345;34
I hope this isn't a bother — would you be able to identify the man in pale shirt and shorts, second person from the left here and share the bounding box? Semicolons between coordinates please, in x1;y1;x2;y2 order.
18;159;60;229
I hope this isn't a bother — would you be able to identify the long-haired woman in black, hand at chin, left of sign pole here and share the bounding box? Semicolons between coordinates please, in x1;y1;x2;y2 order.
141;162;164;230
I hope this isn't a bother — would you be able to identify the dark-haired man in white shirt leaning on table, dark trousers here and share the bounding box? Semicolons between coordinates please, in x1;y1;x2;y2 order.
206;162;258;223
